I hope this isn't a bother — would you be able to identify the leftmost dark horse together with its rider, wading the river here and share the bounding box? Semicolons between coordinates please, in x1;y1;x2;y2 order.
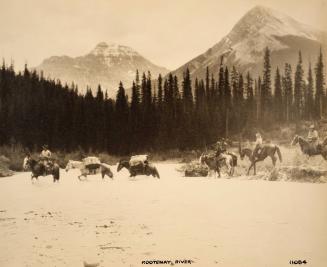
23;149;60;182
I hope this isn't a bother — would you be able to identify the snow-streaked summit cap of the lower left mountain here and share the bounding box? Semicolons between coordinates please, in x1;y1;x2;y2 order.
90;42;139;57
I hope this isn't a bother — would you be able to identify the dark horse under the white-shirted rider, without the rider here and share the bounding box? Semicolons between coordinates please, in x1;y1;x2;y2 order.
239;143;282;175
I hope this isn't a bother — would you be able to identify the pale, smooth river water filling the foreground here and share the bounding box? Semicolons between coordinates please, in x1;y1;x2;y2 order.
0;164;327;267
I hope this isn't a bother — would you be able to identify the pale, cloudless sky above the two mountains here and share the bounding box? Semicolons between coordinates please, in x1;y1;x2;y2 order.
0;0;327;70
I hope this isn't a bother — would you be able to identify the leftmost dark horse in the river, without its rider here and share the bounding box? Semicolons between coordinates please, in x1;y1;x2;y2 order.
23;157;60;182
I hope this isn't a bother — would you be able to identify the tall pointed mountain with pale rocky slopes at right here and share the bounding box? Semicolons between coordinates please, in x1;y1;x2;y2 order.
174;6;327;78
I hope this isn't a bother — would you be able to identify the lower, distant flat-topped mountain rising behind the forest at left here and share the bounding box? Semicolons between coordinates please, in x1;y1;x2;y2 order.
36;42;168;97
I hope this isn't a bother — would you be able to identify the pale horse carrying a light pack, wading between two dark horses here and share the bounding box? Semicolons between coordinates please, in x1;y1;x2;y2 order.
65;157;114;180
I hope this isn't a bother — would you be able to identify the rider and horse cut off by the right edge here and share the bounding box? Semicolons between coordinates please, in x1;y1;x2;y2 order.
291;125;327;160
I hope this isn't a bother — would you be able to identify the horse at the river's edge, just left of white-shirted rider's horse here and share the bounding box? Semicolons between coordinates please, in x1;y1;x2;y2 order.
200;152;237;177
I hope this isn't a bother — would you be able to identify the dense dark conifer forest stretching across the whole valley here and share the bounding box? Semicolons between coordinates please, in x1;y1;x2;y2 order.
0;48;327;154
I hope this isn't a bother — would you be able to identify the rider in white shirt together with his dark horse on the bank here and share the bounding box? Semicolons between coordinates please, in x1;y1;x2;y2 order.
239;133;282;175
